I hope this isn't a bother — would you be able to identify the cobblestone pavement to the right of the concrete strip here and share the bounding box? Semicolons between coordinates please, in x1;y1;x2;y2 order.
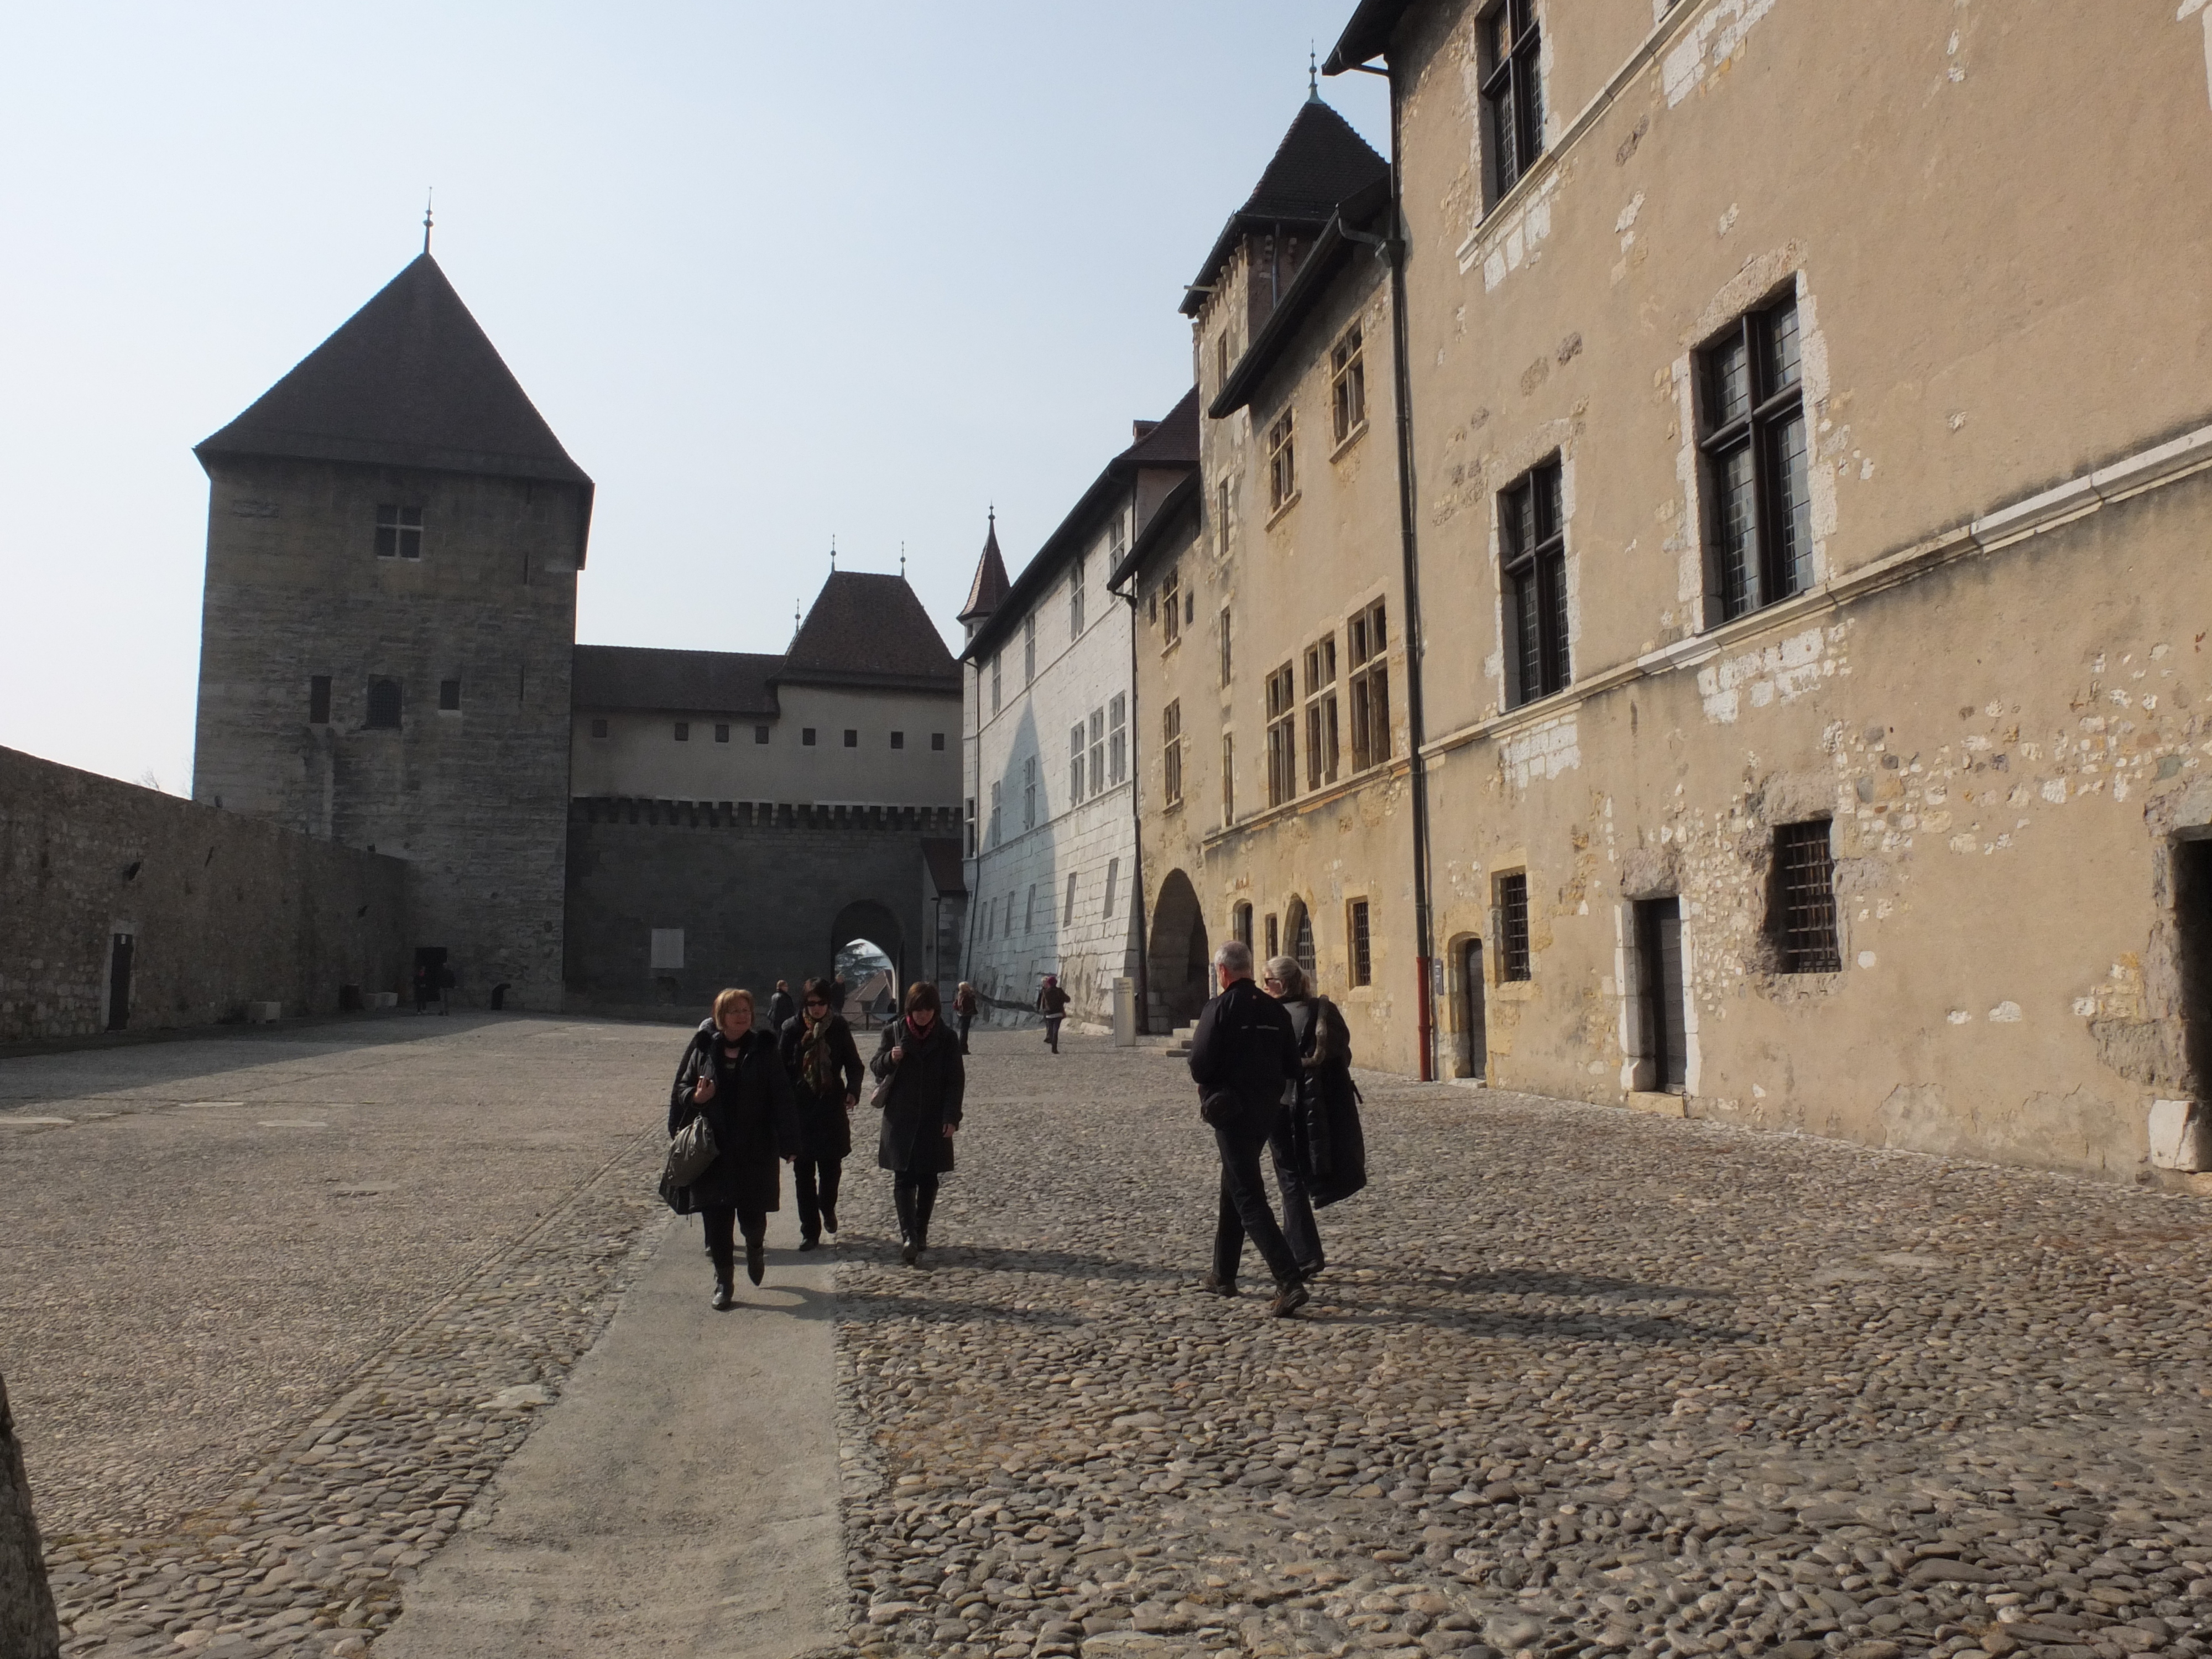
841;1033;2212;1659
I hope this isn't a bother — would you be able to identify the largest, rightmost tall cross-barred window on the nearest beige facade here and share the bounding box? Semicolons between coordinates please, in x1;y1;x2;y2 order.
1697;299;1812;622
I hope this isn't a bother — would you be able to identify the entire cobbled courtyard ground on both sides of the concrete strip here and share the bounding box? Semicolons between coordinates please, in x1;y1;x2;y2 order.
0;1018;2212;1659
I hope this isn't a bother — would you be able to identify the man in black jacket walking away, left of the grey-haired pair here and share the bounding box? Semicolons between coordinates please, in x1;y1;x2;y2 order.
1190;940;1307;1318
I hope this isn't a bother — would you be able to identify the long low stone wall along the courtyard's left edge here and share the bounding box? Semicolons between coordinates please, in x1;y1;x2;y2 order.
0;748;409;1042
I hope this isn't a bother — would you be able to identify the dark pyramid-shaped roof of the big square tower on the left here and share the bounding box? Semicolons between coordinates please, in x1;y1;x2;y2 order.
192;254;591;491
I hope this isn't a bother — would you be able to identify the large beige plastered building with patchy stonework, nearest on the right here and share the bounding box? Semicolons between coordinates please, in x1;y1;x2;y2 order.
1292;0;2212;1179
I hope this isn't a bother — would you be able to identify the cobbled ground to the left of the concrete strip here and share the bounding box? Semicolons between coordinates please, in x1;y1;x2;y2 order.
0;1018;684;1659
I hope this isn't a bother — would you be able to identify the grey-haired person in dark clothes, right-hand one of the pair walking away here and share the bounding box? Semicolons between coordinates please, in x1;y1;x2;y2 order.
1267;956;1367;1279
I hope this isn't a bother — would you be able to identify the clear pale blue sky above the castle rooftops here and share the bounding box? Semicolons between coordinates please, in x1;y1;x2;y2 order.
0;0;1387;792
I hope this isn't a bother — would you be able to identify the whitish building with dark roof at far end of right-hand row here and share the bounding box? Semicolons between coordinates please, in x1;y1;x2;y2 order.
960;394;1199;1026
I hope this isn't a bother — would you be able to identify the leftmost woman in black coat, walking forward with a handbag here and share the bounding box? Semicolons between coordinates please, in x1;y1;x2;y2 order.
668;991;799;1307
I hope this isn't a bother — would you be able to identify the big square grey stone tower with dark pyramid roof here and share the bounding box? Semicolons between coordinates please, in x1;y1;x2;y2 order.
192;252;591;1009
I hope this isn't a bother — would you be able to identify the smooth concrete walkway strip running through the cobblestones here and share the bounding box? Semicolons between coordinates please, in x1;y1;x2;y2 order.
376;1181;849;1659
